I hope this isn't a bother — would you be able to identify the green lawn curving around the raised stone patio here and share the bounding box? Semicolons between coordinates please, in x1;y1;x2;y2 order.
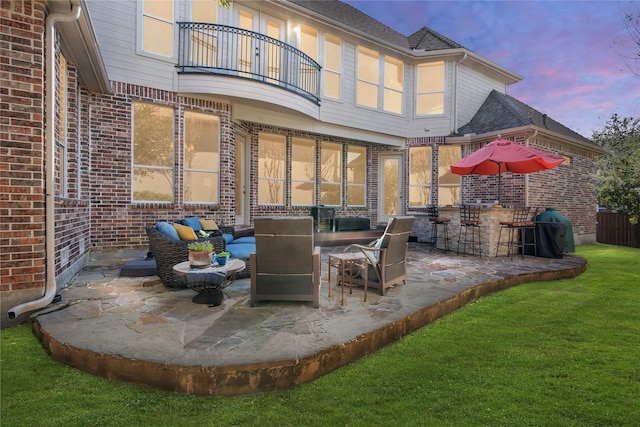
0;245;640;427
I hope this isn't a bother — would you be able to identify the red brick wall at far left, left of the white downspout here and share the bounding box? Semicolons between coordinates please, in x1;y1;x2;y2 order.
0;1;45;313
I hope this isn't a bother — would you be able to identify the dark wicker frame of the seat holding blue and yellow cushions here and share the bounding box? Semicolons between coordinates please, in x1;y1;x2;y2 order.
146;227;226;288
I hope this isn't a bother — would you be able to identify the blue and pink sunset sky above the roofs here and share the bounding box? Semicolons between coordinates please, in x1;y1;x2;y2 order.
344;0;640;138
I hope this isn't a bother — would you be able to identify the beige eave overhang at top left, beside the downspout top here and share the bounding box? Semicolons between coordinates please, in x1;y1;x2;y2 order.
45;0;111;93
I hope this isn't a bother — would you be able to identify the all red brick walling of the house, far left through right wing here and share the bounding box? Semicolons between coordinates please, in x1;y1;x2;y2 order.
0;0;596;324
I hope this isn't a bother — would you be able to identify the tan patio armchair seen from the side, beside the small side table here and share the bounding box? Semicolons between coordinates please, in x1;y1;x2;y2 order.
338;216;415;295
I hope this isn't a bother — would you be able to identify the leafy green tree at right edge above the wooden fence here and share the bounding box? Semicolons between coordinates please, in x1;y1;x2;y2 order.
593;114;640;224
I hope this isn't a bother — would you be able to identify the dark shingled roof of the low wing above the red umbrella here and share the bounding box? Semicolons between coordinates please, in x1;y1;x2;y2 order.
451;90;598;147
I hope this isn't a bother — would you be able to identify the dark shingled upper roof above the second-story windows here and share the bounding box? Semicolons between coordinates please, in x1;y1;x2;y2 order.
291;0;464;51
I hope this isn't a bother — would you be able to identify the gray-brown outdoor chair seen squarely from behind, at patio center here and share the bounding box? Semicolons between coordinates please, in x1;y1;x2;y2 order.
250;216;320;307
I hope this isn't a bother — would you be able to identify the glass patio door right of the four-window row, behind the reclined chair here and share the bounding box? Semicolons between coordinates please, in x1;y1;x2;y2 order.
378;153;404;222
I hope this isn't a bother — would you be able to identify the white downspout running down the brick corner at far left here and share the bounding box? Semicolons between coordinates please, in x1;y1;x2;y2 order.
8;2;82;319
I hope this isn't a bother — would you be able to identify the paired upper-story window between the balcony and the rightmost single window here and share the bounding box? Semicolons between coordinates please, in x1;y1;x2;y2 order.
357;46;404;114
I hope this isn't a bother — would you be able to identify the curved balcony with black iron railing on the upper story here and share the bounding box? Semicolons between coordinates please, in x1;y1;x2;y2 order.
176;22;321;104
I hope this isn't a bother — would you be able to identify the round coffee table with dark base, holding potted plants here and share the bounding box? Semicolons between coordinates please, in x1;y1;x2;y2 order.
173;258;246;306
